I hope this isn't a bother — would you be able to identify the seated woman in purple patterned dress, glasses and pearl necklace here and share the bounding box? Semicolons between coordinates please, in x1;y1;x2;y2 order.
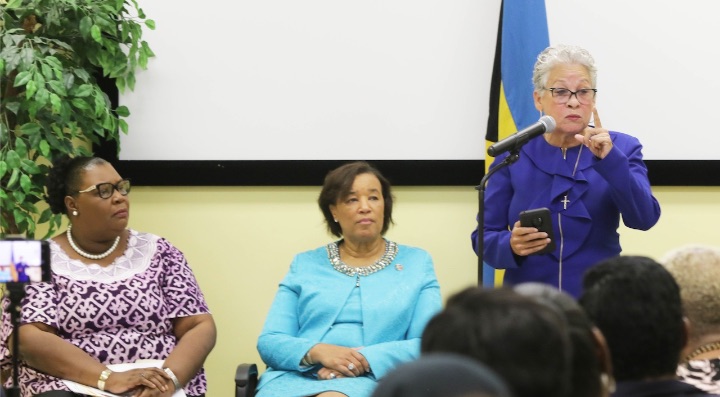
0;157;216;397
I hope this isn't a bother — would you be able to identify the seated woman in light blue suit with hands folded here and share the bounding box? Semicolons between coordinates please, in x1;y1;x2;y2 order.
257;162;442;397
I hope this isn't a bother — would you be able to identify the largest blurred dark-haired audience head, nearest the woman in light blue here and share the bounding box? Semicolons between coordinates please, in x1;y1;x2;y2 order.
421;287;571;397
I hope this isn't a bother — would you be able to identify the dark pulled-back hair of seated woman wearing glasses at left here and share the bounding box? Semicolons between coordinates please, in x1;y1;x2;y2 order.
45;155;108;214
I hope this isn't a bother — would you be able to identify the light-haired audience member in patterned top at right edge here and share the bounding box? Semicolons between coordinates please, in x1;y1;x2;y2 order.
660;245;720;394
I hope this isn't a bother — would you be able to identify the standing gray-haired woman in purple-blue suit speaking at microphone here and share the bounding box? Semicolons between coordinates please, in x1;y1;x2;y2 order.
471;45;660;298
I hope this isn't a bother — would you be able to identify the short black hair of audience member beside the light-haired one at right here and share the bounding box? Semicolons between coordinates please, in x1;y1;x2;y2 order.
580;256;687;381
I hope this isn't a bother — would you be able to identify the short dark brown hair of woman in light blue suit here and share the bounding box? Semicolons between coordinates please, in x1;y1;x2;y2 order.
318;161;394;237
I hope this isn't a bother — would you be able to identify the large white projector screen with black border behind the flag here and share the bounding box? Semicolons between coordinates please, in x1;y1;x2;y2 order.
108;0;720;186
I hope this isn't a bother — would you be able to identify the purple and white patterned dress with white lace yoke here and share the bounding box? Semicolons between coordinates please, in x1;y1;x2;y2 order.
0;230;209;397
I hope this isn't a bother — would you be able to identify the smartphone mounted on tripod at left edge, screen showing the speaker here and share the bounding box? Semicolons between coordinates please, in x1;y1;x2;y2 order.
0;239;50;283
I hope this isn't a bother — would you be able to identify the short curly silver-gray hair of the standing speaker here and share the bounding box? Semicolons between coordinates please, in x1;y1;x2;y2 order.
533;44;597;92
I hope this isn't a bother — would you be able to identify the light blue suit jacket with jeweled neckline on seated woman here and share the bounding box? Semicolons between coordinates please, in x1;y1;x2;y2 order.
257;244;442;387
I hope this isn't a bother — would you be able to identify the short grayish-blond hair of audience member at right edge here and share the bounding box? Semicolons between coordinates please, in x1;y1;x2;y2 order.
660;245;720;338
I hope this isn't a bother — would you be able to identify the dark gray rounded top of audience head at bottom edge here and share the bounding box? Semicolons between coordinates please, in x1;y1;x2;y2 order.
372;353;511;397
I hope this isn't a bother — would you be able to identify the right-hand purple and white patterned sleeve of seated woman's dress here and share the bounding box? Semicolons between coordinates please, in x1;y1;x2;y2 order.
157;239;210;318
